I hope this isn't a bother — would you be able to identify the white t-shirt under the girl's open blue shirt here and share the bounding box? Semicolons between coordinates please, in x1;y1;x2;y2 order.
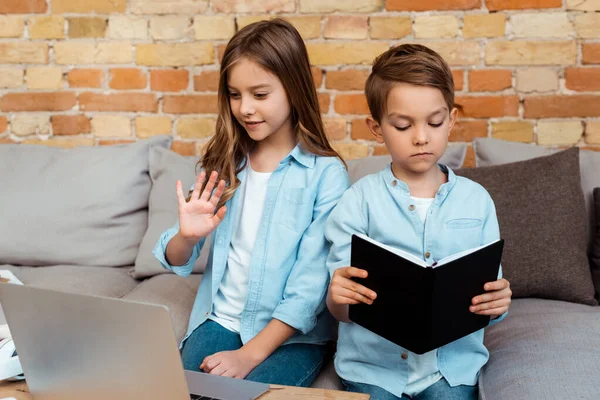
209;163;271;333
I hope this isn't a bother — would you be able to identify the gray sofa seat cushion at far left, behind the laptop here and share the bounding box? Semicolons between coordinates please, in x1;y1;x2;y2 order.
0;265;139;325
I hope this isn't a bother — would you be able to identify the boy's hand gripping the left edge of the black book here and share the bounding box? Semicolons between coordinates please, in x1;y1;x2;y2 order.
329;267;377;304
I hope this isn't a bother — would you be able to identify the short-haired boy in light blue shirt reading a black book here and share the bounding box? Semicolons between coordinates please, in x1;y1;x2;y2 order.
326;45;511;400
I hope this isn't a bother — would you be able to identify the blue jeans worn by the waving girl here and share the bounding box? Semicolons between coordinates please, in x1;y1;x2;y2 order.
181;320;327;387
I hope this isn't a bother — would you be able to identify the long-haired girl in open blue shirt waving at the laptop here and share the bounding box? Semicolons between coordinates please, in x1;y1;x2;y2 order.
154;19;349;386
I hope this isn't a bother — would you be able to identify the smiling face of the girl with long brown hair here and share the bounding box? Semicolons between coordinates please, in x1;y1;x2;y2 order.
227;58;293;146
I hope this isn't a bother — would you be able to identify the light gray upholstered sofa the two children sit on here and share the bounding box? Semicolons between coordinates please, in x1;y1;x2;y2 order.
0;137;600;400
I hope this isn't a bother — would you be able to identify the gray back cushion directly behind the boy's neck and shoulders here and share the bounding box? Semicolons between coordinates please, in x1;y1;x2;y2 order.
347;144;467;183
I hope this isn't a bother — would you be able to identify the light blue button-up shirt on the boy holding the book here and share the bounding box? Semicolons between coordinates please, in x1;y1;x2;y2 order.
325;165;506;397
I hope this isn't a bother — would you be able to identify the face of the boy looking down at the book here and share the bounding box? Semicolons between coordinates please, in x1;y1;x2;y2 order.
367;83;457;176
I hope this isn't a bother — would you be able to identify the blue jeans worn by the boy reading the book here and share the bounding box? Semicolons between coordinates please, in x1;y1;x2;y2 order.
342;378;478;400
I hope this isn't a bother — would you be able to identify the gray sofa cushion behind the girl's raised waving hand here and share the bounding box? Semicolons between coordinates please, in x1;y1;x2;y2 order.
131;147;210;279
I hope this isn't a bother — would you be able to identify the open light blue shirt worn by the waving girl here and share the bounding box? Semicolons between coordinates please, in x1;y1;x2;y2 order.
153;146;350;343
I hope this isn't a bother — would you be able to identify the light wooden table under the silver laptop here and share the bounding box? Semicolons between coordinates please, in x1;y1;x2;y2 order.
0;382;369;400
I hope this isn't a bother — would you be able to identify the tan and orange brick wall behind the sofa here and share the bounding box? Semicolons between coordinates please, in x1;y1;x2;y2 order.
0;0;600;164
